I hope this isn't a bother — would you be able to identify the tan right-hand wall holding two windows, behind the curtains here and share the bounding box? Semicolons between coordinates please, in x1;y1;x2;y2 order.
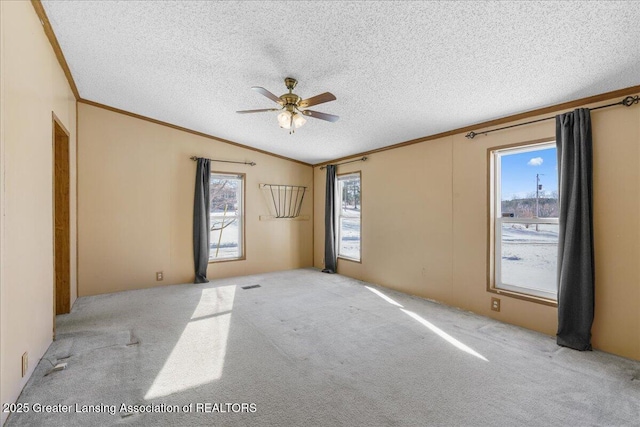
314;93;640;359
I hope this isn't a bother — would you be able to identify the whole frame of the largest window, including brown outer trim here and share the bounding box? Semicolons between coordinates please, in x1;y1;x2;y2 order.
487;138;560;307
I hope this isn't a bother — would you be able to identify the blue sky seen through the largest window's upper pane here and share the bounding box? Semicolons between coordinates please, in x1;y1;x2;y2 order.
501;147;558;200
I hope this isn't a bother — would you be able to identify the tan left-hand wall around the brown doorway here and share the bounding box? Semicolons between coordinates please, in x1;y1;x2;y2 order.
0;1;76;422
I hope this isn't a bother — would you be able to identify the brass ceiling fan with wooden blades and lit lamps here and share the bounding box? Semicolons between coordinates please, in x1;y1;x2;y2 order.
236;77;340;134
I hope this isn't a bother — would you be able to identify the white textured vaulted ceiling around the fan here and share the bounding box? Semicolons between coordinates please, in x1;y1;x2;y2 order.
42;1;640;164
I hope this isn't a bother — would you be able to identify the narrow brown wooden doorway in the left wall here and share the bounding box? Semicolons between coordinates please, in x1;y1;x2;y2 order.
53;114;71;328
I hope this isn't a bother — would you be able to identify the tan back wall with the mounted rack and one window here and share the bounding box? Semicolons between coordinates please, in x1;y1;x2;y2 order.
78;103;313;296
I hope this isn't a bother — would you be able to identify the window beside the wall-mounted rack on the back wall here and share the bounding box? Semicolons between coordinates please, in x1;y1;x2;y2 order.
209;172;244;262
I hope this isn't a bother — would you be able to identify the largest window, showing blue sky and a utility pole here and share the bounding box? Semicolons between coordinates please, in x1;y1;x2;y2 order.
489;142;559;301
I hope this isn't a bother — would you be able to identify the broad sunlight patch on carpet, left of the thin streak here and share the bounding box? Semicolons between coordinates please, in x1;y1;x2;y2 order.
144;285;236;400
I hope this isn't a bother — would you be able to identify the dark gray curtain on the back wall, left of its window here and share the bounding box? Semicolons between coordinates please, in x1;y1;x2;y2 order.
193;159;211;283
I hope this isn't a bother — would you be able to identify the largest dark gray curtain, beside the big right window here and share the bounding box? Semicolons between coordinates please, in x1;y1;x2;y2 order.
556;108;595;351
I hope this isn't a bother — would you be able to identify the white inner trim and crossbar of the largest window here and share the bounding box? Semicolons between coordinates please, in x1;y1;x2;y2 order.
489;141;559;303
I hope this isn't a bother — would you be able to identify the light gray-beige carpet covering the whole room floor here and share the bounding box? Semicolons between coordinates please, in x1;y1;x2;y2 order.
7;269;640;426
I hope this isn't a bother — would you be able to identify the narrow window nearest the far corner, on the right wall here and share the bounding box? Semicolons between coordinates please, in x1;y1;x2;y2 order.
338;172;361;261
